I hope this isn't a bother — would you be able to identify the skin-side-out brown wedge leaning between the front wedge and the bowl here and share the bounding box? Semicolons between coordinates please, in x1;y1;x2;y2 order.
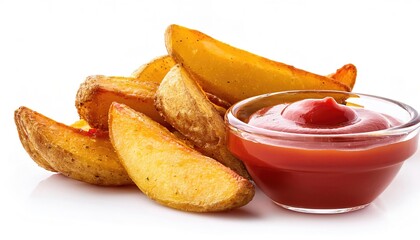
155;65;249;178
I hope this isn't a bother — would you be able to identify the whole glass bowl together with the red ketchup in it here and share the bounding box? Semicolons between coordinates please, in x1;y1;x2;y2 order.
225;91;420;213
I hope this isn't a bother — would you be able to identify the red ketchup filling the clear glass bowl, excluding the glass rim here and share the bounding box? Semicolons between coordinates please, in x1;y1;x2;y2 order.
228;97;418;209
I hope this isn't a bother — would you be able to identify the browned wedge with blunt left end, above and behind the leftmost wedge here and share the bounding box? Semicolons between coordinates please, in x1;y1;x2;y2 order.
76;75;169;130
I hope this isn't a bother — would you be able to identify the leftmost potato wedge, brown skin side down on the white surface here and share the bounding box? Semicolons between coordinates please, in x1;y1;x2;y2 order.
15;107;133;186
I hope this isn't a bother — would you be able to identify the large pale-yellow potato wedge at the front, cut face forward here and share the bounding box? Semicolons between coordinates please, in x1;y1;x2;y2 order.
109;103;255;212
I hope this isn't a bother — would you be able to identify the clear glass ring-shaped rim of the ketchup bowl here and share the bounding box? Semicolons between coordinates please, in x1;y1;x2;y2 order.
224;90;420;141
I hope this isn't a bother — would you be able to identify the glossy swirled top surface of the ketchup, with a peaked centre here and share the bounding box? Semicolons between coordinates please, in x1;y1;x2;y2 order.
248;97;401;134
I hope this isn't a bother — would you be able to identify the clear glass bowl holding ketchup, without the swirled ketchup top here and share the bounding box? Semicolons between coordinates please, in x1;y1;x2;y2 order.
225;90;420;213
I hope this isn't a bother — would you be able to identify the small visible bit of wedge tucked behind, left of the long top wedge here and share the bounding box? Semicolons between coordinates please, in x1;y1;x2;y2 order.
131;55;175;84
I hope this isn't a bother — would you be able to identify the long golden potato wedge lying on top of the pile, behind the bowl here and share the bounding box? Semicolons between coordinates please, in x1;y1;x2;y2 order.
165;25;351;103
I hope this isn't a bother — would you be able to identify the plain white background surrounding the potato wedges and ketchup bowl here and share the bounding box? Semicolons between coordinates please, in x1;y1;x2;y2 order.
0;0;420;239
